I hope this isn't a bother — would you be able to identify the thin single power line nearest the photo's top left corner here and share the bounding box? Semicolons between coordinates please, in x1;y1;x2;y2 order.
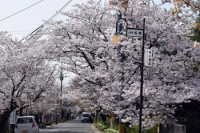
0;0;45;22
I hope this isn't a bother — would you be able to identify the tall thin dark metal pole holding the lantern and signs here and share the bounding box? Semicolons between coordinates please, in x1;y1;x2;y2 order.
139;18;145;133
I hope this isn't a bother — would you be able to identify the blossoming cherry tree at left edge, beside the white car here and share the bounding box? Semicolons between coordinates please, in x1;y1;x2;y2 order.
0;32;55;131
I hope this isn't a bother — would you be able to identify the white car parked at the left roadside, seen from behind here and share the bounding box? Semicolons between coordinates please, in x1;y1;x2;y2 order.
15;116;39;133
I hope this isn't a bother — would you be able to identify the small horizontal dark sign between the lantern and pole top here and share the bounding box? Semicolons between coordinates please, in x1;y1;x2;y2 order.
126;28;144;37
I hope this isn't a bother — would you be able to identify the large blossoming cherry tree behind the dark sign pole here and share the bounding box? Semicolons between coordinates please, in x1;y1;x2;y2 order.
48;0;199;126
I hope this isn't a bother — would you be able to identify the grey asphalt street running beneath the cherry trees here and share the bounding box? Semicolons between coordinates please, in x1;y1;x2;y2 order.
40;120;97;133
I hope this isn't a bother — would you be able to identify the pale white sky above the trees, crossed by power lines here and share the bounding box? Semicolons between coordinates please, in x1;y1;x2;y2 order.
0;0;87;38
